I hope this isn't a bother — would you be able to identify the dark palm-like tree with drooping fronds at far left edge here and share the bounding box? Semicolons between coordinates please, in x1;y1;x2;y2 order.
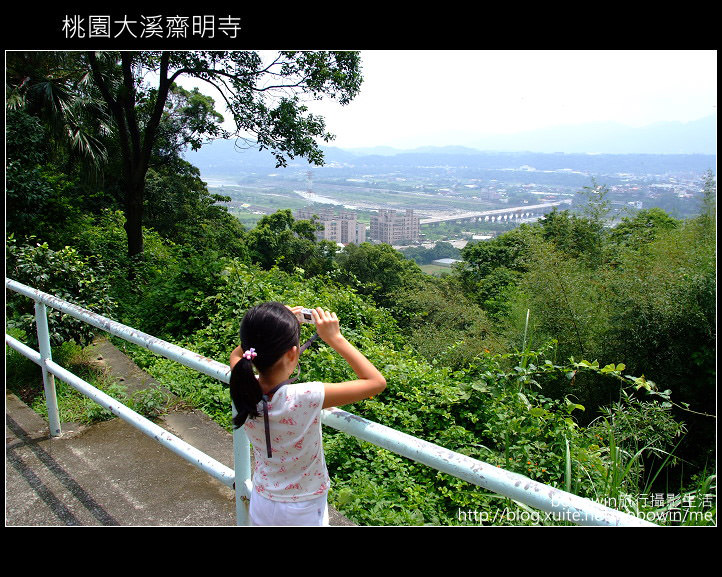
5;51;109;246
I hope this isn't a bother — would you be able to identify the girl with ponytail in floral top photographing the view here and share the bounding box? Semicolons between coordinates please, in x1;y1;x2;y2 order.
230;302;386;525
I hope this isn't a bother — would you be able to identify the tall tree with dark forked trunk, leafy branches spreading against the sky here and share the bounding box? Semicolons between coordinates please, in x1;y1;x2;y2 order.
85;51;361;257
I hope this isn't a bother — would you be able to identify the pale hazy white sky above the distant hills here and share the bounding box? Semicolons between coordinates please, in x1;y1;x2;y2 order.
302;50;717;148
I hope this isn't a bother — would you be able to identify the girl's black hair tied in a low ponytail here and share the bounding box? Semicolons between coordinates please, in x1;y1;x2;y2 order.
230;302;301;428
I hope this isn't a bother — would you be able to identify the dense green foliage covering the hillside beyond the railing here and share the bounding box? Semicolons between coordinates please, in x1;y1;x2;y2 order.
6;51;716;525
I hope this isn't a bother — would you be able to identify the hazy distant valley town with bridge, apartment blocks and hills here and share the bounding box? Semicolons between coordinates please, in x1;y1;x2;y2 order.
190;141;716;255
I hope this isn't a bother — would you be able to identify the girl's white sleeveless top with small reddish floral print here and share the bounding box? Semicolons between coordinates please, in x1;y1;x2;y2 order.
243;382;330;502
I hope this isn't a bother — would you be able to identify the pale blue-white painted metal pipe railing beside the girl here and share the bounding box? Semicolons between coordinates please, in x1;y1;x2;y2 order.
5;279;654;526
